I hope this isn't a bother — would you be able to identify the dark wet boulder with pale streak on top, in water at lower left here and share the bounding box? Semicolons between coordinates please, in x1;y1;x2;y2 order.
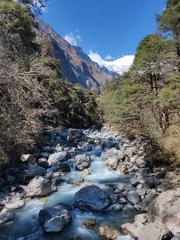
39;204;71;233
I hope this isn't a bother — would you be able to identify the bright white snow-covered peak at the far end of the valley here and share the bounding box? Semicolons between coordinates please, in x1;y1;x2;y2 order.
88;50;134;75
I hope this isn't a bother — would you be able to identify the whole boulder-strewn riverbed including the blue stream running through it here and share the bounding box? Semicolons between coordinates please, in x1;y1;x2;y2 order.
0;127;180;240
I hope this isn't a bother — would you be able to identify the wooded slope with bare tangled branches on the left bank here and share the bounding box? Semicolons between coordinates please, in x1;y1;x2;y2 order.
0;0;101;168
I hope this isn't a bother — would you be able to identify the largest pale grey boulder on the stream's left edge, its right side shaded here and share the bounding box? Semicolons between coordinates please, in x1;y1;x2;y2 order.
28;177;57;197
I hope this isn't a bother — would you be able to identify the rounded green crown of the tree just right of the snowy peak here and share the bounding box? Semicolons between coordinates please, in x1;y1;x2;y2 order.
133;35;171;95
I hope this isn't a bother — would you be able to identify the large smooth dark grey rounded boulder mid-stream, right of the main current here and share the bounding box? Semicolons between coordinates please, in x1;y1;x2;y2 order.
74;185;110;211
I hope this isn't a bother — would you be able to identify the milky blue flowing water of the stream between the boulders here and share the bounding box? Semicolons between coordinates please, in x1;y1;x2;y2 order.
0;130;137;240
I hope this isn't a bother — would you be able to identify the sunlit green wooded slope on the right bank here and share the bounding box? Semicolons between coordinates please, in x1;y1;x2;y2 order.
101;0;180;160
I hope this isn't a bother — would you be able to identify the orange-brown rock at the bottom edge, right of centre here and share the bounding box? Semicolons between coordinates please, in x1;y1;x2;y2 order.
98;223;120;240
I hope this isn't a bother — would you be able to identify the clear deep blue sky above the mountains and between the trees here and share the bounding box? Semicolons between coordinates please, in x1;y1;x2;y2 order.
42;0;166;59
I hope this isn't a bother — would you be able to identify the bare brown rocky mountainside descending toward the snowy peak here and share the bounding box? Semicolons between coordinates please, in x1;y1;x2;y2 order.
38;21;117;89
